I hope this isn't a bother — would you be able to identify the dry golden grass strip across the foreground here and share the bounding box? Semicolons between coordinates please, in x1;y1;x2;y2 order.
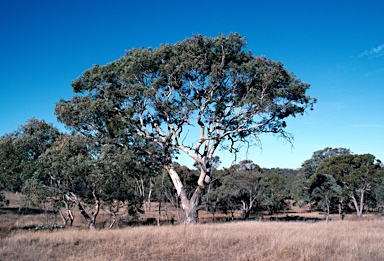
0;220;384;260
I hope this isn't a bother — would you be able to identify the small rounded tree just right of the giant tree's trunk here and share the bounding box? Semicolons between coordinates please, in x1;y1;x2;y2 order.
203;160;287;218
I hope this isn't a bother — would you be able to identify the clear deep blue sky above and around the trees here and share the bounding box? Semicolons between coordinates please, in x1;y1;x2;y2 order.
0;0;384;168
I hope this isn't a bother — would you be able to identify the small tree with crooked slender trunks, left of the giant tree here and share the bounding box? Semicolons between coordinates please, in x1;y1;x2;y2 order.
23;134;100;229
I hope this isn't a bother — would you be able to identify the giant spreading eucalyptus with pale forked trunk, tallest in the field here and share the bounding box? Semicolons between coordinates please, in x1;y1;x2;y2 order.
56;34;315;223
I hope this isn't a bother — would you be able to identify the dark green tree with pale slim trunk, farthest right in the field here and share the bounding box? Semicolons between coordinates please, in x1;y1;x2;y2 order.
316;154;384;217
